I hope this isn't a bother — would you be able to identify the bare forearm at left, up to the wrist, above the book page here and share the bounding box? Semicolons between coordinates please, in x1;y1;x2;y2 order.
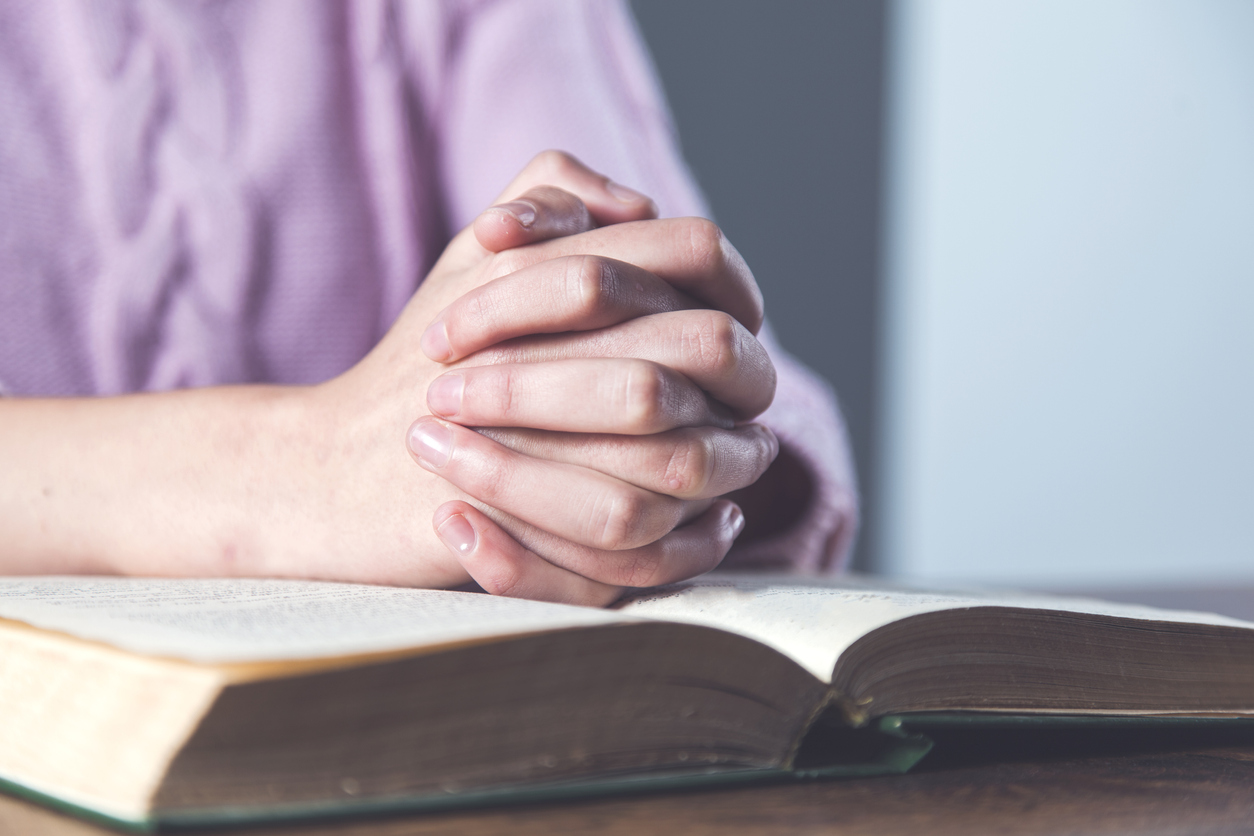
0;386;328;575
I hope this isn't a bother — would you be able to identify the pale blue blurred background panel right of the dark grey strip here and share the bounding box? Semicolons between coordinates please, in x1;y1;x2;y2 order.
877;0;1254;587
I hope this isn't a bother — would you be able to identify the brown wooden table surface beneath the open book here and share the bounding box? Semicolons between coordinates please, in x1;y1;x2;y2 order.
0;589;1254;836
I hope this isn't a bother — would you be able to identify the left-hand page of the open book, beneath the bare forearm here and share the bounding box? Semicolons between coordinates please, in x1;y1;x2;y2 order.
0;577;633;663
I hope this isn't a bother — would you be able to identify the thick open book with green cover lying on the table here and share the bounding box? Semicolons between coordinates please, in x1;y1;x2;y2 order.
0;574;1254;828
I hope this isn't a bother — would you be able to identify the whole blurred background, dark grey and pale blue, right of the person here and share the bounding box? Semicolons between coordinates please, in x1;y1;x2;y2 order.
632;0;1254;589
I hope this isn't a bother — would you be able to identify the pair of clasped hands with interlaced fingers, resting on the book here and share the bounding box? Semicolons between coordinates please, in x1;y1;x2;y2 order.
324;152;779;605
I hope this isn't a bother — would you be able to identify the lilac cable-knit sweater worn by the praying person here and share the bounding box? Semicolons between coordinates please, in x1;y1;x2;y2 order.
0;0;858;568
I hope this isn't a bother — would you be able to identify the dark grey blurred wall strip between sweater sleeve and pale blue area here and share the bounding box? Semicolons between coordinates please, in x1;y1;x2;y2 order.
632;0;887;568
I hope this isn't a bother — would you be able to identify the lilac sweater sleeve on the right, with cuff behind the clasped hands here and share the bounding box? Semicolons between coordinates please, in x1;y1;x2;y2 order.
419;0;858;570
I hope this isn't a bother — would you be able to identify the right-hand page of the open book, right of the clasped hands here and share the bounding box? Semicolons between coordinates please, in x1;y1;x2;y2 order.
618;572;1254;682
